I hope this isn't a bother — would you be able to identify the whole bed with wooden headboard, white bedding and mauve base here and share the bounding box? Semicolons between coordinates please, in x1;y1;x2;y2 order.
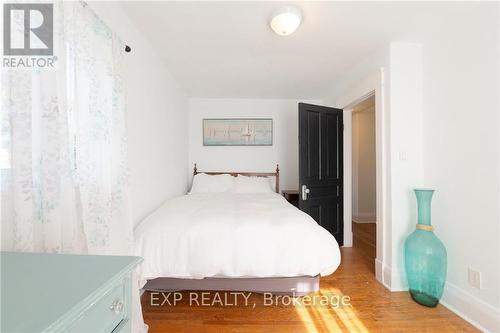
135;165;340;296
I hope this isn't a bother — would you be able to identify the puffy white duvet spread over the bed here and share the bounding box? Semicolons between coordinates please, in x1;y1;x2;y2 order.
135;193;340;283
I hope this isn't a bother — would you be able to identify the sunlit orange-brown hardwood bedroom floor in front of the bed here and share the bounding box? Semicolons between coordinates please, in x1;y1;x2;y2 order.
142;248;479;333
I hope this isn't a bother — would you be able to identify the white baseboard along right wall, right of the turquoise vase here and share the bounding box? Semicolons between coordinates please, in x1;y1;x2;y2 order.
440;282;500;333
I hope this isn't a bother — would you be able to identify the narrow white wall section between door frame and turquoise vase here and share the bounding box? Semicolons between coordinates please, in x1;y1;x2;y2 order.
389;43;424;290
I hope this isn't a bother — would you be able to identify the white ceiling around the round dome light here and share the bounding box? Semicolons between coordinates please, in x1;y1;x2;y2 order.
122;1;442;99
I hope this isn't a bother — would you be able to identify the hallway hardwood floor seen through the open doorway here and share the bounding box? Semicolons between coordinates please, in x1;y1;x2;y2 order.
352;221;377;274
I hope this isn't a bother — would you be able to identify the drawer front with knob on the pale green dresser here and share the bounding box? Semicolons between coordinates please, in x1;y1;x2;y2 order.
69;279;129;333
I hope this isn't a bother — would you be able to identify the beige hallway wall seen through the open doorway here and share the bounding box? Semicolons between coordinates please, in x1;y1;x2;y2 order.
352;104;377;223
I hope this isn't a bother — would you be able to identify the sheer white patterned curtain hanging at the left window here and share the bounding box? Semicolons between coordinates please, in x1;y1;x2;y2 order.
0;2;142;331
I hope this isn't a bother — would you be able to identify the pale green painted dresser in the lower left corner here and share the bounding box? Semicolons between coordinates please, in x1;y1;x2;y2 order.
0;252;142;333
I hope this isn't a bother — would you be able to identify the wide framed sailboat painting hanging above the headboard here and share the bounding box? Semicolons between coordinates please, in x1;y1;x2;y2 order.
203;119;273;146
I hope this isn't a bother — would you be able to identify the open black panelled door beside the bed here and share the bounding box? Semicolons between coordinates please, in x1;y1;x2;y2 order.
299;103;344;245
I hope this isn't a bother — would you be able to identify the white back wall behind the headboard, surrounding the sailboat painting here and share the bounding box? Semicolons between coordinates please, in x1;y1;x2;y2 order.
188;99;322;190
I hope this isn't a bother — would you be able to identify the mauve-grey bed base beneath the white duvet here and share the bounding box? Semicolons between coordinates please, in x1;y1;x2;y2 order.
144;275;319;296
